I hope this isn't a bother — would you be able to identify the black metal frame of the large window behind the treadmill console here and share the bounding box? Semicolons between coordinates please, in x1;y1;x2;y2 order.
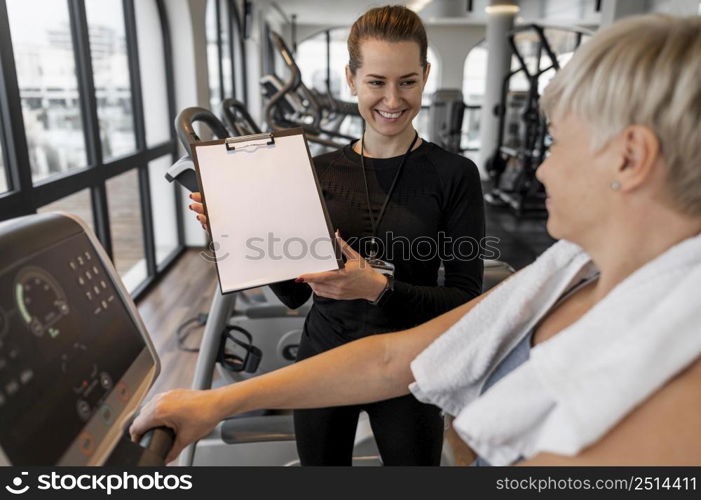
0;0;185;299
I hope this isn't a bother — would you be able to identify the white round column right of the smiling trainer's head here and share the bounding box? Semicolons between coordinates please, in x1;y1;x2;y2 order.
477;0;518;178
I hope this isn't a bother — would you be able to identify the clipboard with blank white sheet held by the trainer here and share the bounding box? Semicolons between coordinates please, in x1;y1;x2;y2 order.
192;128;343;293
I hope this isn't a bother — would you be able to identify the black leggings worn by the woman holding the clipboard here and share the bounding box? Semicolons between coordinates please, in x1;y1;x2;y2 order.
294;341;443;465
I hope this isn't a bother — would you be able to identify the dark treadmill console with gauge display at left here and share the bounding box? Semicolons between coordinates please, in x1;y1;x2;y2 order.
0;214;158;465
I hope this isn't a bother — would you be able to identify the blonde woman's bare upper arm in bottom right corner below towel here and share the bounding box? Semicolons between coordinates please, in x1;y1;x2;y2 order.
518;360;701;466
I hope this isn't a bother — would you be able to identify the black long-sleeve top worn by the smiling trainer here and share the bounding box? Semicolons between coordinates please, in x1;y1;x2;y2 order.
271;141;484;352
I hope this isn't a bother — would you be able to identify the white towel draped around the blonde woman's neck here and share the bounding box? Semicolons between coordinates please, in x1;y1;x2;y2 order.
410;236;701;465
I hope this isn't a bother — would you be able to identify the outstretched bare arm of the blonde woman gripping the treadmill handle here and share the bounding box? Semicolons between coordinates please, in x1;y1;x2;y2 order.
130;294;487;461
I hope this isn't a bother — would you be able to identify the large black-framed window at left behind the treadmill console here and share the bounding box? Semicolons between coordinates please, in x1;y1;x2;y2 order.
0;0;184;297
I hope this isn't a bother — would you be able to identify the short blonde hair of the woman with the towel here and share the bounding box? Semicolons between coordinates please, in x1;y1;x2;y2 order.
540;14;701;216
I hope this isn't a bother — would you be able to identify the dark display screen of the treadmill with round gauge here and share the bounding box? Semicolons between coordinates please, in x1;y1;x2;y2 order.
0;233;145;465
